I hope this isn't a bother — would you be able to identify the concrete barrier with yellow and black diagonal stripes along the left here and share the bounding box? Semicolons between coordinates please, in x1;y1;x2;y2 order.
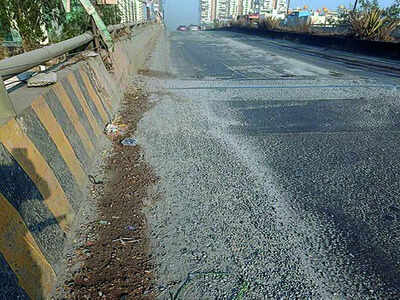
0;25;162;299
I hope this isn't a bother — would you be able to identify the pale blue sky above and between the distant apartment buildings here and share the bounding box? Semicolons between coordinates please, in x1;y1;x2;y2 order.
164;0;393;29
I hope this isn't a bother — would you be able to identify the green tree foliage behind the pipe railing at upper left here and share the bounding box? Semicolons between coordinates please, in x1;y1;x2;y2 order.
0;0;121;51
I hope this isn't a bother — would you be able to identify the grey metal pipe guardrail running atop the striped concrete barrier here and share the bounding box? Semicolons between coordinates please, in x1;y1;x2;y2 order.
0;22;147;79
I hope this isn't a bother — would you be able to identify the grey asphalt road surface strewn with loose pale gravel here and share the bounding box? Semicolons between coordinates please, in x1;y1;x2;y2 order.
138;32;400;299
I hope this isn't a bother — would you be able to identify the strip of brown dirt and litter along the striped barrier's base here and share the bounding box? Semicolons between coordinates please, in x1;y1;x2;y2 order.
58;82;157;299
